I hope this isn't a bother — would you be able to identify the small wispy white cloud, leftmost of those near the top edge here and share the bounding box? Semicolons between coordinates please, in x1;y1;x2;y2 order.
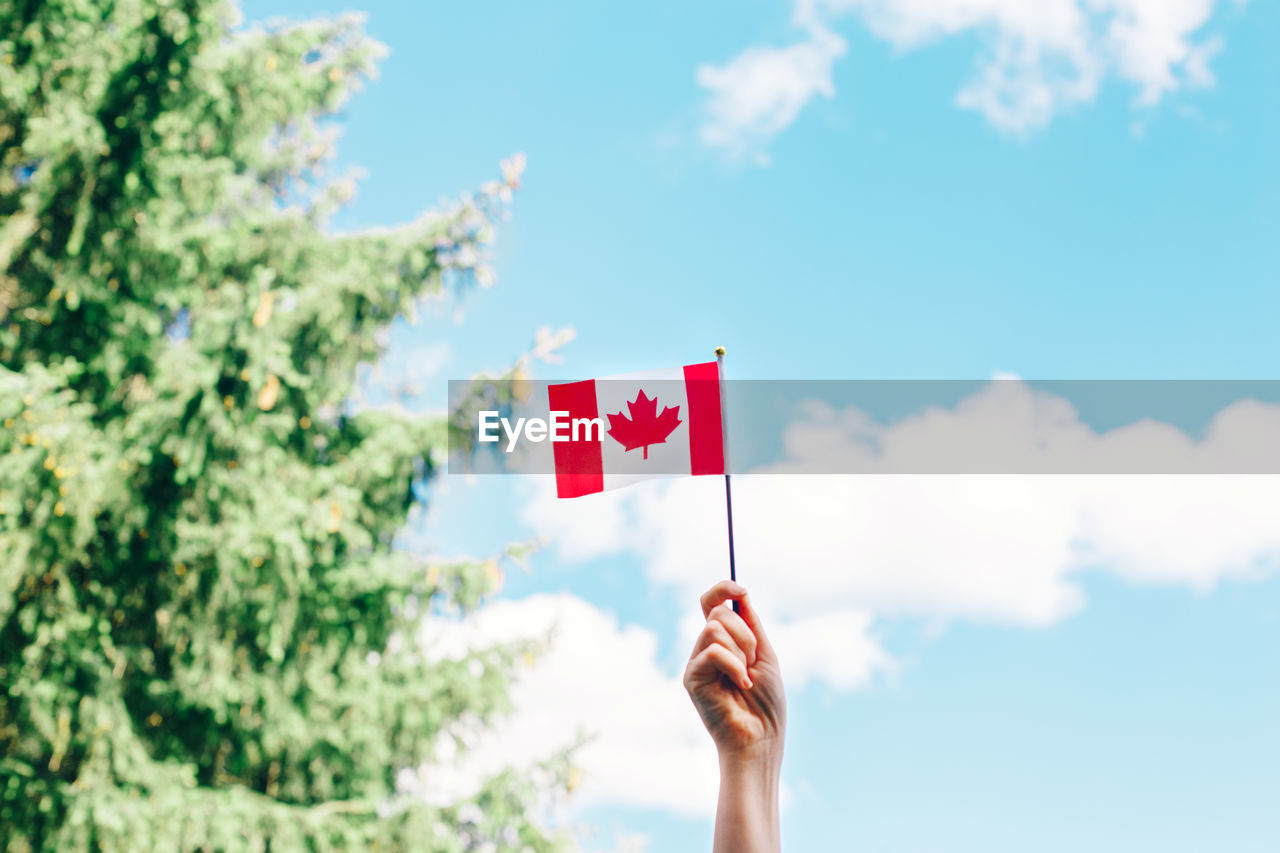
698;27;845;161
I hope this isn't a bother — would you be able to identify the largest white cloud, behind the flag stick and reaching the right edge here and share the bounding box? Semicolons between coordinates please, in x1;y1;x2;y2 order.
526;382;1280;630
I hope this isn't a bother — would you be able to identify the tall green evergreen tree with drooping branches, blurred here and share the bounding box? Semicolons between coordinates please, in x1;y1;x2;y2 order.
0;0;563;852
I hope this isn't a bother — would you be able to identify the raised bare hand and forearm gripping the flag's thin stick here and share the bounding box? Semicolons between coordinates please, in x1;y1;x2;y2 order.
685;580;787;853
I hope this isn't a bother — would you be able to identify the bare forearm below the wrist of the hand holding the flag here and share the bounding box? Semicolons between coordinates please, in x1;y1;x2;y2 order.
713;745;782;853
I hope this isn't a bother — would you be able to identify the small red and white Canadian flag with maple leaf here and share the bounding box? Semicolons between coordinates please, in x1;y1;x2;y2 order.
547;361;724;498
